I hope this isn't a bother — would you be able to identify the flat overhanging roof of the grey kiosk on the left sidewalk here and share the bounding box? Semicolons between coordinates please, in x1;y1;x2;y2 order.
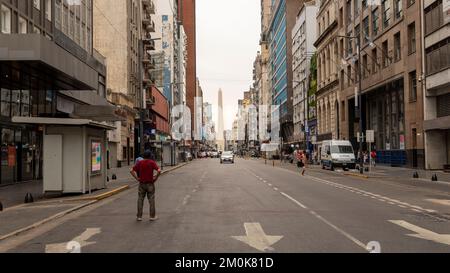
11;117;116;130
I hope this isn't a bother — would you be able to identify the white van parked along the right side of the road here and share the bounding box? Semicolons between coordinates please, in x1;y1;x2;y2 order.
320;140;356;171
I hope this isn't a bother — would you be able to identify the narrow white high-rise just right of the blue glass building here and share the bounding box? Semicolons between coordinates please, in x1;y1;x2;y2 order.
292;1;318;148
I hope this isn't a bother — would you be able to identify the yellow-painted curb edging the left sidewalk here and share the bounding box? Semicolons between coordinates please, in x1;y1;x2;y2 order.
0;163;188;242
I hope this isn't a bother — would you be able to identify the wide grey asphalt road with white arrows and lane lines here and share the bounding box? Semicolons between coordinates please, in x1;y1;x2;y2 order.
0;159;450;253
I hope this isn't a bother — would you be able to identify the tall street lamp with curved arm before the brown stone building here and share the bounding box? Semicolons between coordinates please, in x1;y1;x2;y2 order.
337;35;364;174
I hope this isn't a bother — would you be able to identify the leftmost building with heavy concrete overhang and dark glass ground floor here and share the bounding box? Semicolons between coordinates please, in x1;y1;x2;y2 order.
0;0;109;185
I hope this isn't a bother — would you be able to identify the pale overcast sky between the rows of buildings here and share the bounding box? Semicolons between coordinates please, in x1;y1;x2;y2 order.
196;0;261;129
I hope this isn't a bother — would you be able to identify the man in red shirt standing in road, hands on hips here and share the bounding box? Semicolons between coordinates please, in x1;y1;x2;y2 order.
130;150;161;222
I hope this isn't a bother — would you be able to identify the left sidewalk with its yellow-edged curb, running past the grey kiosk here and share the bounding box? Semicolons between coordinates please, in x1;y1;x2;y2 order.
0;163;186;242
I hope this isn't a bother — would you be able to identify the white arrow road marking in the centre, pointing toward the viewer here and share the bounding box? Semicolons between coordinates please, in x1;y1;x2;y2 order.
232;223;283;252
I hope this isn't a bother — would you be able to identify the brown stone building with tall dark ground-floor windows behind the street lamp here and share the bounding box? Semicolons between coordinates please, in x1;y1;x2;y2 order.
330;0;424;168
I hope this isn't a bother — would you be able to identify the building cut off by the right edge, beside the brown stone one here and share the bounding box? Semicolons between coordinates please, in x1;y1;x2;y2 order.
424;0;450;169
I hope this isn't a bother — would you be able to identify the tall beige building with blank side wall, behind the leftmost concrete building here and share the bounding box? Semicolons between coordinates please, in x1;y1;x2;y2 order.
93;0;155;166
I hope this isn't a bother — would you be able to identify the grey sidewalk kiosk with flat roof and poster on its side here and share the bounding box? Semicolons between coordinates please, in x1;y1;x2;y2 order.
14;117;115;194
